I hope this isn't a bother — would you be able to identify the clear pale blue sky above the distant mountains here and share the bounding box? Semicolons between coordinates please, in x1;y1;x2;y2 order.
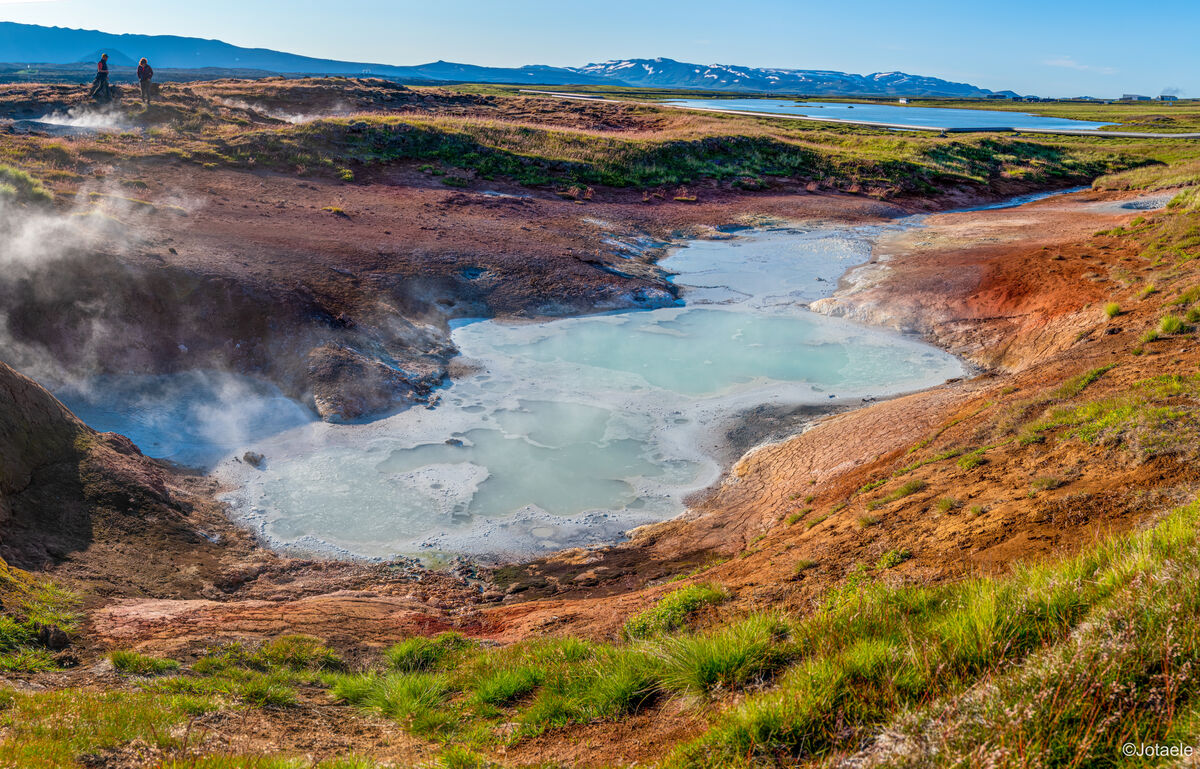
0;0;1200;96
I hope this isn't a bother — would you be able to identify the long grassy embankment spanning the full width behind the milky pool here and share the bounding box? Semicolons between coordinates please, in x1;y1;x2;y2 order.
0;80;1200;198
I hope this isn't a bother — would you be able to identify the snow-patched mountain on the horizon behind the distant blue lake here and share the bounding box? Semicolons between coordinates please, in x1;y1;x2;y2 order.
574;59;991;96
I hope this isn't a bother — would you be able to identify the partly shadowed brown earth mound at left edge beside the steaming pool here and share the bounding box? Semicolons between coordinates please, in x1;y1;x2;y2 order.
0;362;248;597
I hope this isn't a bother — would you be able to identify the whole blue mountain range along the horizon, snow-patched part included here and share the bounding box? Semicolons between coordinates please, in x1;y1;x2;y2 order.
0;22;1009;97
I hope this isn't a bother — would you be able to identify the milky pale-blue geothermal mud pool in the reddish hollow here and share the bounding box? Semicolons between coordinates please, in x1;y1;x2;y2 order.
64;218;964;557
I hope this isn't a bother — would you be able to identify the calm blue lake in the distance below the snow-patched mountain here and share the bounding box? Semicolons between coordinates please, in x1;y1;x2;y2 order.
666;98;1110;130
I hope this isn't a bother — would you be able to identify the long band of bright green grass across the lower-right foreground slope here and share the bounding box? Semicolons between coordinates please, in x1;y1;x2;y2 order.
285;503;1200;769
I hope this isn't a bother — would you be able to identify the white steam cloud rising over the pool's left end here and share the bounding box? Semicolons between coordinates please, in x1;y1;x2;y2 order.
0;190;313;467
